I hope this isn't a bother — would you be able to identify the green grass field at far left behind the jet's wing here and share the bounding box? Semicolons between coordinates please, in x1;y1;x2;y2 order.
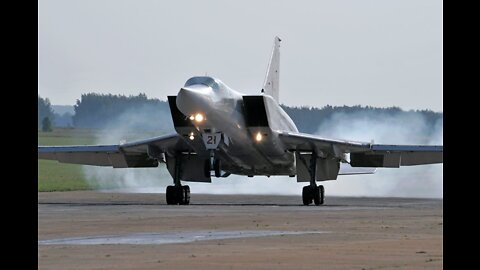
38;128;166;191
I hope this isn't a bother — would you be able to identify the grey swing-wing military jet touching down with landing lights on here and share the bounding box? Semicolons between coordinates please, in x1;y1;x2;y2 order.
38;37;443;205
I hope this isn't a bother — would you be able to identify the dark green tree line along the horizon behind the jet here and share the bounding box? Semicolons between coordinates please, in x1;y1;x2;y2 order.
38;93;443;133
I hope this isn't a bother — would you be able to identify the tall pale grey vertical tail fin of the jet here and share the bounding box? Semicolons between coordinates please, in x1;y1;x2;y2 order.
262;36;282;103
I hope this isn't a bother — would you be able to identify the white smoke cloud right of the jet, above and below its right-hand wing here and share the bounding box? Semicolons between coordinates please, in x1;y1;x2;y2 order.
316;111;443;198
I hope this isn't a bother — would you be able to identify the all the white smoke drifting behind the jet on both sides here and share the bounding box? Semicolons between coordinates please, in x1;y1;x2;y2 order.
83;108;443;198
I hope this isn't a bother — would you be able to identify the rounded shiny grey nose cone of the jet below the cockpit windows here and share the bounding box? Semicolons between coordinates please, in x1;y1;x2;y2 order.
177;84;212;116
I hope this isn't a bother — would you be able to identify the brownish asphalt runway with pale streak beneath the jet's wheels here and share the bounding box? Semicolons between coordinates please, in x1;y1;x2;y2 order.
38;191;443;270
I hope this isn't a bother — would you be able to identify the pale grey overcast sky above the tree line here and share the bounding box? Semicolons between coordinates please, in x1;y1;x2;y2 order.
38;0;443;111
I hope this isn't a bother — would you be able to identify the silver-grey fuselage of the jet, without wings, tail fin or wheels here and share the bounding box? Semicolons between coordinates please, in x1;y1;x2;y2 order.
176;77;298;175
